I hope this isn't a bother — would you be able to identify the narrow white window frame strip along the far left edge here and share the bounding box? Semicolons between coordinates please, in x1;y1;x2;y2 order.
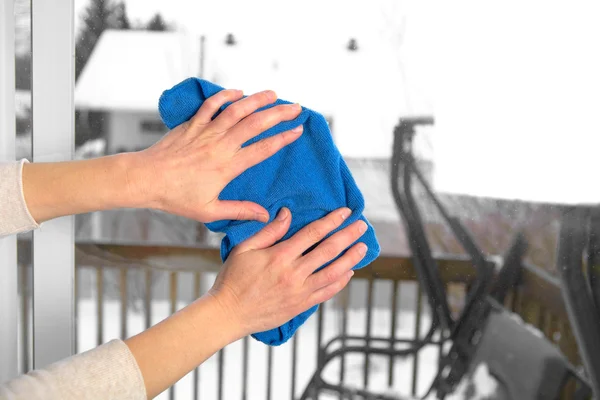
0;0;19;383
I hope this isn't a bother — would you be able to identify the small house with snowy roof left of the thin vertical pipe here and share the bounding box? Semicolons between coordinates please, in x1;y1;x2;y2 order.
75;30;200;154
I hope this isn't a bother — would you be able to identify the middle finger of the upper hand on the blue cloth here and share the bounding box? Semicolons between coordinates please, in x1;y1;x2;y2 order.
228;104;302;147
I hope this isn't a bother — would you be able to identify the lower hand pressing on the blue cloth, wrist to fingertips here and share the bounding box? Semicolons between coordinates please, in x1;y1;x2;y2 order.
209;208;367;337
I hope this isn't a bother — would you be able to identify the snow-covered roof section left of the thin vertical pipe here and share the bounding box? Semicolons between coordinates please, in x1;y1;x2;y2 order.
75;30;200;111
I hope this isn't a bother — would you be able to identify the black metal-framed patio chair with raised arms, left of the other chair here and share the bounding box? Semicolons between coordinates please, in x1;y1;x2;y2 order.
301;117;588;400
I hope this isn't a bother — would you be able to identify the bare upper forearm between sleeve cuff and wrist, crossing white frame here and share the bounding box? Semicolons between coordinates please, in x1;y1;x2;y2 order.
23;154;143;223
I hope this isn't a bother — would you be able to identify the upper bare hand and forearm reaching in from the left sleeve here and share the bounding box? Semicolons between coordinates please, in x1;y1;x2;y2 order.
23;90;302;223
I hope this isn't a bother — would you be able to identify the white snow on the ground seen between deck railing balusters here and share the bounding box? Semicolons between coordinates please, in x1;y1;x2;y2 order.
77;299;446;400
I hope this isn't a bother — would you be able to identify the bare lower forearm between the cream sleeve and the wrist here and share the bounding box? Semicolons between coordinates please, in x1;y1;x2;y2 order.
125;295;244;398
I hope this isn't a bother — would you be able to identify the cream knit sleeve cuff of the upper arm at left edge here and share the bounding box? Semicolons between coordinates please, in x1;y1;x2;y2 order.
0;159;39;237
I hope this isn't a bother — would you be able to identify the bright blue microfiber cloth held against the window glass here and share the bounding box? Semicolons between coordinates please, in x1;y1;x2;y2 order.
159;78;380;345
